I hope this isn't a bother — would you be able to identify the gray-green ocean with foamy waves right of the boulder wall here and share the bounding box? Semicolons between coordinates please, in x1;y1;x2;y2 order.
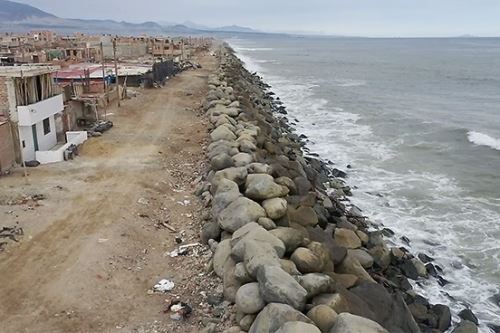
227;35;500;332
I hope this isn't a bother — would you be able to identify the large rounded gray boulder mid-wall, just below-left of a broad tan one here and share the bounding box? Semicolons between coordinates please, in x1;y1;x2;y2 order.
218;197;266;232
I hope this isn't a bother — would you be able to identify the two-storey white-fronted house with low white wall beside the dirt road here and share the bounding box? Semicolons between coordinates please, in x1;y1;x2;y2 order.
0;66;86;163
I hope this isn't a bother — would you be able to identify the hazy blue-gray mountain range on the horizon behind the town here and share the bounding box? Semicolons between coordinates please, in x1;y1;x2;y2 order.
0;0;259;35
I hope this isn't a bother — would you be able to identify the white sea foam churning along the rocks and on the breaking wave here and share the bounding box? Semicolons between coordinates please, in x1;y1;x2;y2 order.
229;40;500;333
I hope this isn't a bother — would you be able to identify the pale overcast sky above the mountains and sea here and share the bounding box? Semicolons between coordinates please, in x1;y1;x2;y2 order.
19;0;500;36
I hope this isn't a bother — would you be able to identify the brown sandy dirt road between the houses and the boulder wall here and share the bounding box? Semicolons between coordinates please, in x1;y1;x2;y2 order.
0;51;216;333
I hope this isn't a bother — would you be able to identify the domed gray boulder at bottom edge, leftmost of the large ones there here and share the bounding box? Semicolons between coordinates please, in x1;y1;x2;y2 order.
248;303;312;333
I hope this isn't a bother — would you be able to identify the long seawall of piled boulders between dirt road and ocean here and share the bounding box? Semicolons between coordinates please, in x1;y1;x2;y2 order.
198;47;478;333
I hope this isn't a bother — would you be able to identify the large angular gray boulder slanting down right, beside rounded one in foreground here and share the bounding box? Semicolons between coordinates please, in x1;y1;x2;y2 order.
257;266;307;310
